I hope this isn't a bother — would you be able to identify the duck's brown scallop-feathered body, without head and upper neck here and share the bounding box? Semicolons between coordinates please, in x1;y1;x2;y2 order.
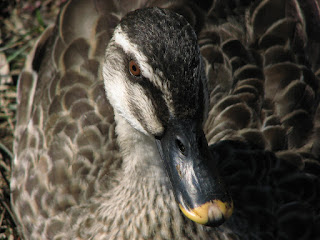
11;0;320;240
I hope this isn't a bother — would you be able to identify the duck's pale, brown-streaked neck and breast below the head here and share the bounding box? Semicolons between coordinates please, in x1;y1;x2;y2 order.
92;113;224;240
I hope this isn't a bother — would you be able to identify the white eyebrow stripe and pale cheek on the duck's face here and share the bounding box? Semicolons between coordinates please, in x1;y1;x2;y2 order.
103;27;175;135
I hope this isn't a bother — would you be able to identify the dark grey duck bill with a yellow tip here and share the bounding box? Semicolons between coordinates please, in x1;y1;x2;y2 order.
156;120;233;226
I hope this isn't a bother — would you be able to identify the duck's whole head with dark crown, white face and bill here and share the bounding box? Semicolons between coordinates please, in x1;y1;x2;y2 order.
103;8;233;226
